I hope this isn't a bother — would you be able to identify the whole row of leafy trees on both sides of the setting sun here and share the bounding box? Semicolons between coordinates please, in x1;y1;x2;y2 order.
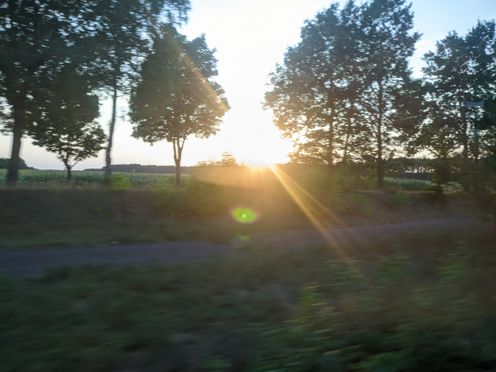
0;0;496;189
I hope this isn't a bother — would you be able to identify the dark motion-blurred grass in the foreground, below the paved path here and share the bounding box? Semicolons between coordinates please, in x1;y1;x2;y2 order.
0;230;496;371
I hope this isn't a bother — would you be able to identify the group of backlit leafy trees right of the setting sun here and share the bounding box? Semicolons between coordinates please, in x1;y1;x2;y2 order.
265;0;496;189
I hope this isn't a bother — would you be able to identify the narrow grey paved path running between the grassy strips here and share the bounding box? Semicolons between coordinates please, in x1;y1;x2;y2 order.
0;217;481;277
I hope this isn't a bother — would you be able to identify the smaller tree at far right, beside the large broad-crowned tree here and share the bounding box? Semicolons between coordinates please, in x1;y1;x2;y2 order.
424;21;496;190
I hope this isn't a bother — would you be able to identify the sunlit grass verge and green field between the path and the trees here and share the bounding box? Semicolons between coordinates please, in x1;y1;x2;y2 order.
0;166;488;248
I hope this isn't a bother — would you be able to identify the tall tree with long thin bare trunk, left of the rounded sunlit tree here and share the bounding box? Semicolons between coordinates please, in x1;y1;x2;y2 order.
87;0;189;181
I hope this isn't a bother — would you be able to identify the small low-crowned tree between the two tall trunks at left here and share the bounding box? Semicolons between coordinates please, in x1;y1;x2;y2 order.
30;65;106;181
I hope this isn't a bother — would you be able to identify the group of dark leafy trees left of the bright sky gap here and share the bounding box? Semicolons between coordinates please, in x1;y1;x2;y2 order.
0;0;229;184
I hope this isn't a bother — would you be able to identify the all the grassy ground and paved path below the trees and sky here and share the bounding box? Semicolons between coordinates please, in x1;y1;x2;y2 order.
0;171;496;371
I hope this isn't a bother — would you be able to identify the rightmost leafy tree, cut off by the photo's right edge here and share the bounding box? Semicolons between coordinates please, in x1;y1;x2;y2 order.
418;21;496;190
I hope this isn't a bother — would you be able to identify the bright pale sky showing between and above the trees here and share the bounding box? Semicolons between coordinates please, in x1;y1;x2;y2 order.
0;0;496;169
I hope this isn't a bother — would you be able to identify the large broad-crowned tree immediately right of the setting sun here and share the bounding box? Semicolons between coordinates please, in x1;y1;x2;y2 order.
266;0;421;187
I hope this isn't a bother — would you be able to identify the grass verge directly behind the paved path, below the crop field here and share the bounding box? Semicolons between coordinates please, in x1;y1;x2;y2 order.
0;180;480;249
